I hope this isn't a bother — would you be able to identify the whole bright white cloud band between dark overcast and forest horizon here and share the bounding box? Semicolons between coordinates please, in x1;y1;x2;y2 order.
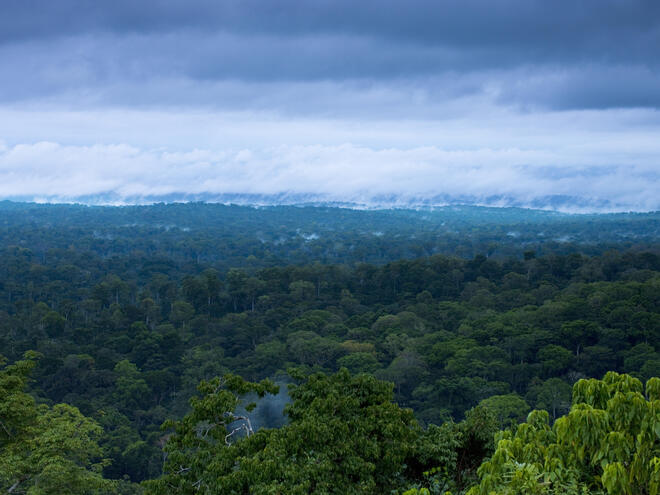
0;106;660;211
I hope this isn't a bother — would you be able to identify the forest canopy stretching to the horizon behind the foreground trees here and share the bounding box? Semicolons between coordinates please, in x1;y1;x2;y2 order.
0;202;660;482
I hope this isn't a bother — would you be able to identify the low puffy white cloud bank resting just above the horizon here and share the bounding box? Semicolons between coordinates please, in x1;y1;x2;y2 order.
0;138;660;211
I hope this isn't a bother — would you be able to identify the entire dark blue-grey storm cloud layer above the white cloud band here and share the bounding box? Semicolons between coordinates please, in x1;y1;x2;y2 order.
0;0;660;112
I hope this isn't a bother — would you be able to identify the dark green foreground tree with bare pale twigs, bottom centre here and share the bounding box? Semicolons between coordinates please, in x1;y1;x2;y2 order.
146;370;420;494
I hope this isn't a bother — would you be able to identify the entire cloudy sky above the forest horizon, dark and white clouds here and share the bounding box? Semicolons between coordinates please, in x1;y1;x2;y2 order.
0;0;660;211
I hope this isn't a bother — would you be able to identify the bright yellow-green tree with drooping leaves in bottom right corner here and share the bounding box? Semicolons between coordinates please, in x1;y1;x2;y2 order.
468;372;660;495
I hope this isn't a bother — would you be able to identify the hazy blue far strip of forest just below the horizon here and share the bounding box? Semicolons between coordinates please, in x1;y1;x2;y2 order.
0;201;660;268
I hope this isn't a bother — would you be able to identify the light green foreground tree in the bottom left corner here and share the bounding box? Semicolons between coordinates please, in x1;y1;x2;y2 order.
0;354;115;495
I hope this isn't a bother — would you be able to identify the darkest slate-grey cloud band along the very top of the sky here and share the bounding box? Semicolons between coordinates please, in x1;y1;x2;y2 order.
0;0;660;62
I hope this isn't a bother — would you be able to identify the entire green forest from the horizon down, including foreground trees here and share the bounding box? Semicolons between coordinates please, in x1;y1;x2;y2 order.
0;203;660;494
